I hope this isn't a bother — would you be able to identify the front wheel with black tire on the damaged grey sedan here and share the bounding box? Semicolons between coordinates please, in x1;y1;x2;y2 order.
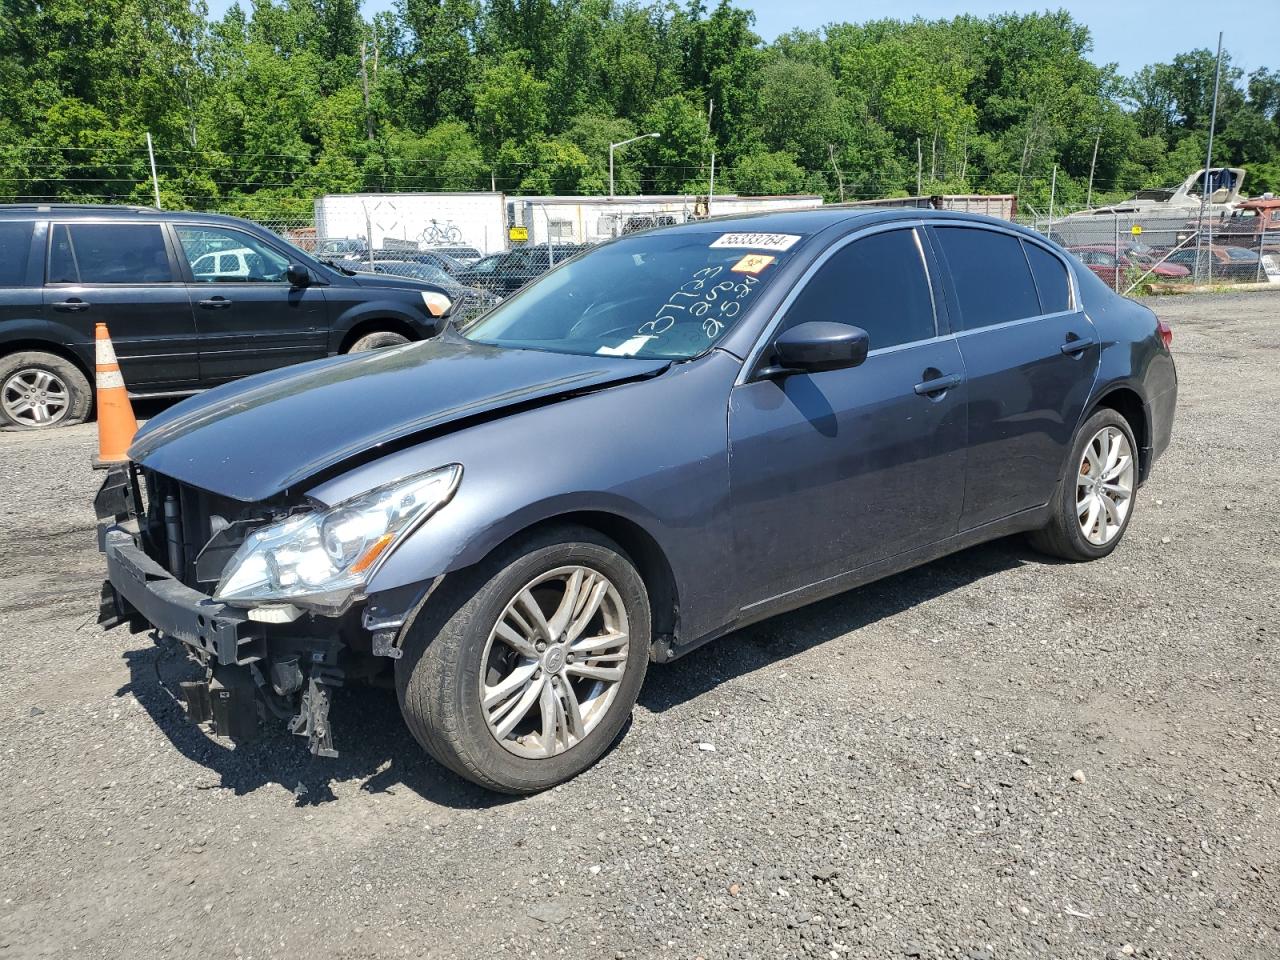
396;527;650;794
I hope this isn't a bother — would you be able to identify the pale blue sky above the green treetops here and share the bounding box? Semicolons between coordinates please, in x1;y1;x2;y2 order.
209;0;1280;74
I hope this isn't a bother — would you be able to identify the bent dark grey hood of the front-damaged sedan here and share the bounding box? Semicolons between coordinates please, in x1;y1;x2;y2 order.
129;337;669;502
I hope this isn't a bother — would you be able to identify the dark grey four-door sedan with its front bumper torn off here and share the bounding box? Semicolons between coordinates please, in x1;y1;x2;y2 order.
96;209;1176;792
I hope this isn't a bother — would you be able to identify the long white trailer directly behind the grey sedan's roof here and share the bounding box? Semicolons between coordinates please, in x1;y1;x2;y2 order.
507;193;822;244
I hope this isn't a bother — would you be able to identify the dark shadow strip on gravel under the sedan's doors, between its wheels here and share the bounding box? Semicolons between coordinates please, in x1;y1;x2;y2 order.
640;536;1039;713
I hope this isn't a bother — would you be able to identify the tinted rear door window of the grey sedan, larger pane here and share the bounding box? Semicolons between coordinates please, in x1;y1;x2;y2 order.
934;227;1041;330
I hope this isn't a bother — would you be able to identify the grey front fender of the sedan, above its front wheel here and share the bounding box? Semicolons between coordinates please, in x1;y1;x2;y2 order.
308;352;741;636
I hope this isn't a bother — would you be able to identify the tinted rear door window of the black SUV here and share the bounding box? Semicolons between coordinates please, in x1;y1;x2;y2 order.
49;223;174;283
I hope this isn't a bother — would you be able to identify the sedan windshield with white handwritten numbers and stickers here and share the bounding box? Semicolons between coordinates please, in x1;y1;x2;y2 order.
465;230;801;358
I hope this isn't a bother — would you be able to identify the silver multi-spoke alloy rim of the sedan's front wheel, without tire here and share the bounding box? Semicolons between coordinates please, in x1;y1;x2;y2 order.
480;566;630;758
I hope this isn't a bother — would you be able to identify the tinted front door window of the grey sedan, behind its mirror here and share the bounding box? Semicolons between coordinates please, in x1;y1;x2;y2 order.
782;229;937;349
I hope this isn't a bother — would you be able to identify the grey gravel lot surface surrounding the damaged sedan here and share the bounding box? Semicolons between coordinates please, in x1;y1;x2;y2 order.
0;293;1280;960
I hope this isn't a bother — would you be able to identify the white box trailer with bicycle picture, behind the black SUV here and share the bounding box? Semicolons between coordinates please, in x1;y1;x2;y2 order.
315;192;507;253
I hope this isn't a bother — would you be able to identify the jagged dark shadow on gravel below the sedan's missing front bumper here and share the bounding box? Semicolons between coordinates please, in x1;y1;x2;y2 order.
116;640;517;809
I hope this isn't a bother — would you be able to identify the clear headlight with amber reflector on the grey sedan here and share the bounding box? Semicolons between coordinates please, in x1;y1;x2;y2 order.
214;463;462;616
